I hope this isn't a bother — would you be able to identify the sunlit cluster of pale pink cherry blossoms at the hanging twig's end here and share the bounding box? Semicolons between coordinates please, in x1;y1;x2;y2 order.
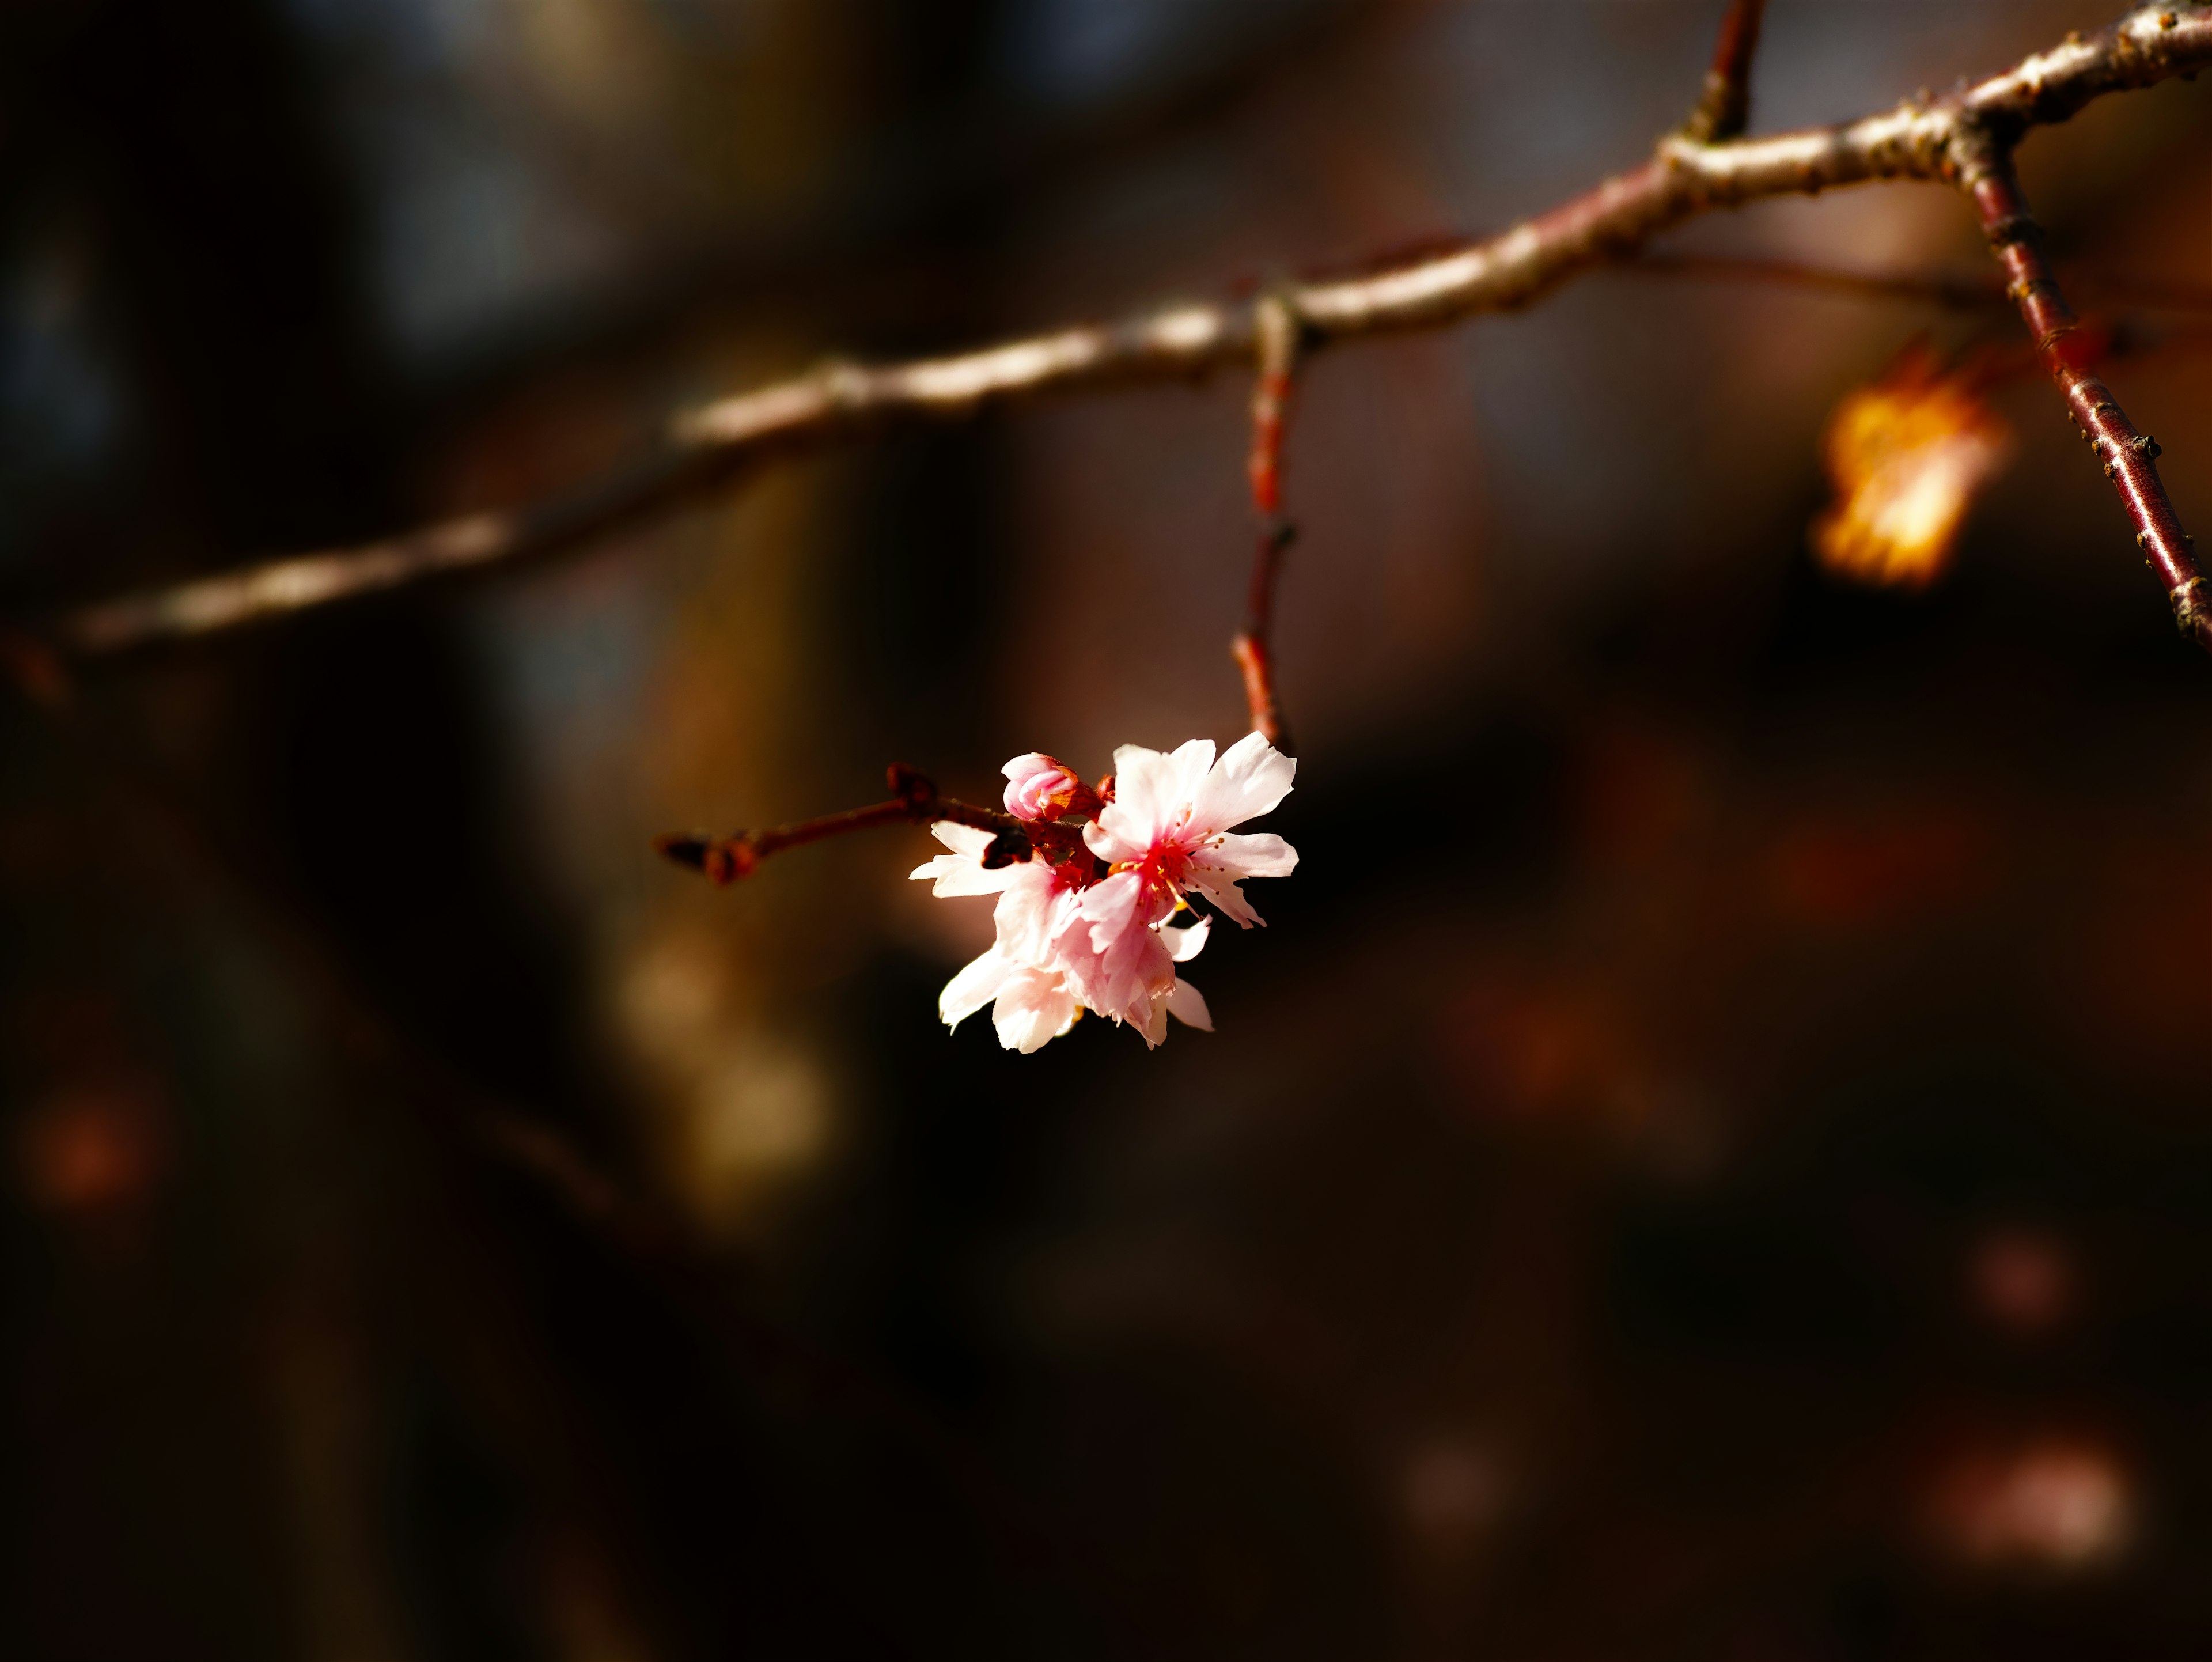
914;733;1298;1054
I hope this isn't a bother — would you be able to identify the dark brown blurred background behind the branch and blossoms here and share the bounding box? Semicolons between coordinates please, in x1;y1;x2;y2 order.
13;0;2212;1662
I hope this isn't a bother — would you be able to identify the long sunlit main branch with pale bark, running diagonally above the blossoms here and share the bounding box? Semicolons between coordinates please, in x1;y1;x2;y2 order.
30;7;2212;660
